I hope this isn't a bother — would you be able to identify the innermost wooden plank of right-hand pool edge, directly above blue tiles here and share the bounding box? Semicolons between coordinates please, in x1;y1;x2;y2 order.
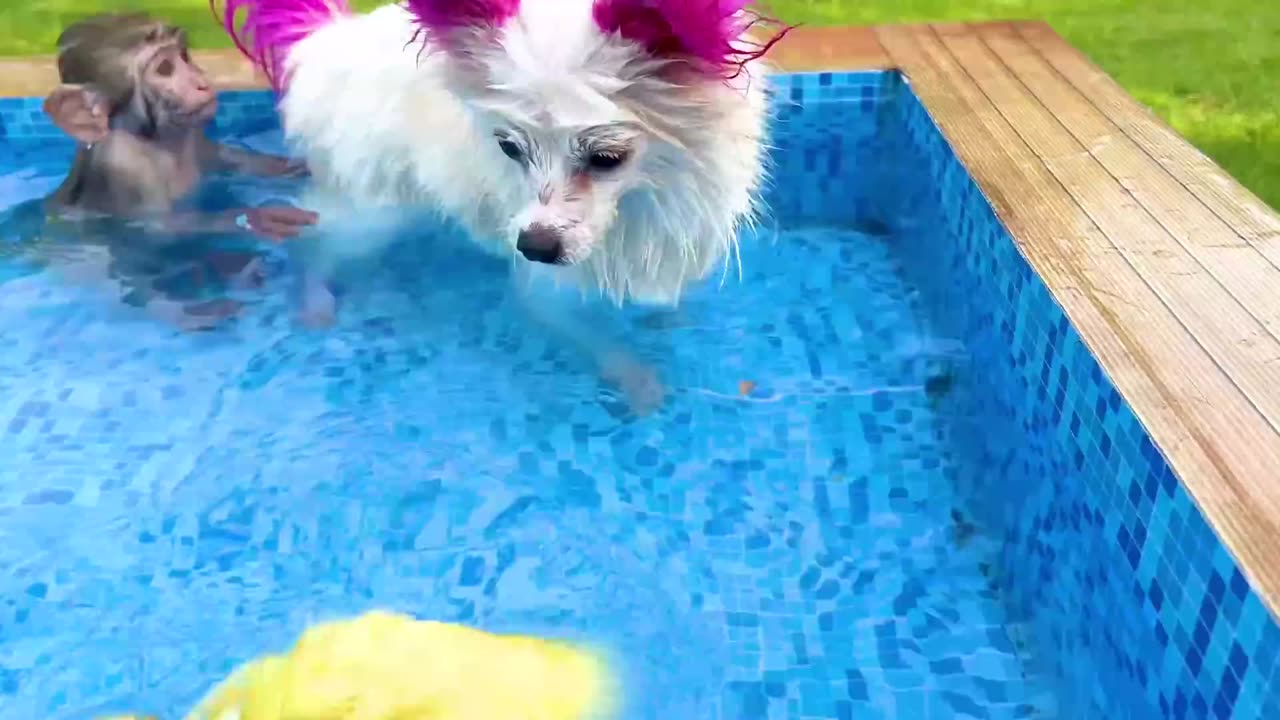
878;27;1280;612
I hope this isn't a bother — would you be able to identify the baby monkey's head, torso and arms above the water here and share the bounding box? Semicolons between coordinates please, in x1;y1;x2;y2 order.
45;13;316;240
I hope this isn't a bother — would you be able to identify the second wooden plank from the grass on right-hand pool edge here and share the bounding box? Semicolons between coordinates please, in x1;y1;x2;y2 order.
975;23;1280;337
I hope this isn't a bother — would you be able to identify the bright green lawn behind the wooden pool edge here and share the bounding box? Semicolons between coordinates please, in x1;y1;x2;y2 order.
0;0;1280;208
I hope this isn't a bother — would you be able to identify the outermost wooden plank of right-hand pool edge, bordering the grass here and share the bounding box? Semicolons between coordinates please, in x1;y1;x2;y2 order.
1018;23;1280;265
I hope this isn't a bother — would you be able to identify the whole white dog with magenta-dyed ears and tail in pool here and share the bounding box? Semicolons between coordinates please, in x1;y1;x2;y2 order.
212;0;781;404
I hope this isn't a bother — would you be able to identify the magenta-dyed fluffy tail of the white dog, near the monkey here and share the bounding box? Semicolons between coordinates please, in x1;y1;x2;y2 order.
209;0;351;94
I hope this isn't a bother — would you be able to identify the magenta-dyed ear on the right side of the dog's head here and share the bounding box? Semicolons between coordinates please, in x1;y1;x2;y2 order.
593;0;790;77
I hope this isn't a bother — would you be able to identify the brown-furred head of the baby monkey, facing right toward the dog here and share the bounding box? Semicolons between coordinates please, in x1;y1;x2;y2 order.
58;13;218;137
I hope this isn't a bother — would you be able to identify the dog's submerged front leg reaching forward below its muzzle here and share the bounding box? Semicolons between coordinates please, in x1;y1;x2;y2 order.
511;261;666;415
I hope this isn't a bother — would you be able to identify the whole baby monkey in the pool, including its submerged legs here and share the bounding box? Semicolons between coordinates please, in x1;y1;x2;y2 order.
21;13;325;328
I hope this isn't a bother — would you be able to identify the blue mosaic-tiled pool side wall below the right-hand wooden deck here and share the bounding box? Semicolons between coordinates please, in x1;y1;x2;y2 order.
863;71;1280;719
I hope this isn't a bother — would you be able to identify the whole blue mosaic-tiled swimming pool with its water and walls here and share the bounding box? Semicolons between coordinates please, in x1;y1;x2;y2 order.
0;73;1280;720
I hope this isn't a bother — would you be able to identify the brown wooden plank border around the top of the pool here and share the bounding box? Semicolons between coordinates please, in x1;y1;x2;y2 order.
0;22;1280;616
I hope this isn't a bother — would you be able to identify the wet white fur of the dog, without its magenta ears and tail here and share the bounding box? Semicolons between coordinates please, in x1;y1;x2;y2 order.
282;0;767;304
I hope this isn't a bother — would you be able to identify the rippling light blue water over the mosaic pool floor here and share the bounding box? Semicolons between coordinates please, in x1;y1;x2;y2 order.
0;119;1053;720
